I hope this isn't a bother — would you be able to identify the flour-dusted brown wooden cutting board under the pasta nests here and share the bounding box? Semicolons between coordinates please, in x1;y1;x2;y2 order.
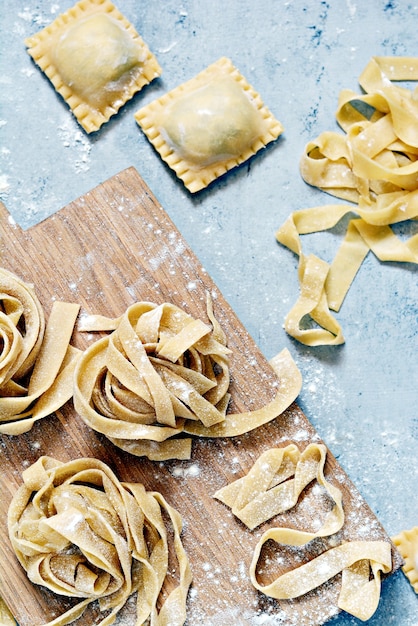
0;168;401;626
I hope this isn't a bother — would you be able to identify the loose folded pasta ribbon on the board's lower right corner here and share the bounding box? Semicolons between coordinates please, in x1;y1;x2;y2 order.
214;443;392;620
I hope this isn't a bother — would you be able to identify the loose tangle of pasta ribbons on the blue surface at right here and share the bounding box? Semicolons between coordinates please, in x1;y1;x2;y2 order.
276;57;418;346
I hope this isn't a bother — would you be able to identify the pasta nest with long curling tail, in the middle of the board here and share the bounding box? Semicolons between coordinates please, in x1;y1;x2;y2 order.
73;298;301;460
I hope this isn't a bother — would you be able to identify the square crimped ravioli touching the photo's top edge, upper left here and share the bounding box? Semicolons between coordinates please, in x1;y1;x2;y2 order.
25;0;161;133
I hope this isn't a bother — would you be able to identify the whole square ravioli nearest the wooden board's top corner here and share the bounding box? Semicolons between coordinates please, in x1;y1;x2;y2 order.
135;57;283;193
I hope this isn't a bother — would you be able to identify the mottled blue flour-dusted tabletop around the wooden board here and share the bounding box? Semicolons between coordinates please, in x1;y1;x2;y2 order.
0;0;418;626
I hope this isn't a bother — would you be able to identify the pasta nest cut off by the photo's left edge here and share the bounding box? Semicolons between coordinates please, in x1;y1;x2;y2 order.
0;268;80;435
